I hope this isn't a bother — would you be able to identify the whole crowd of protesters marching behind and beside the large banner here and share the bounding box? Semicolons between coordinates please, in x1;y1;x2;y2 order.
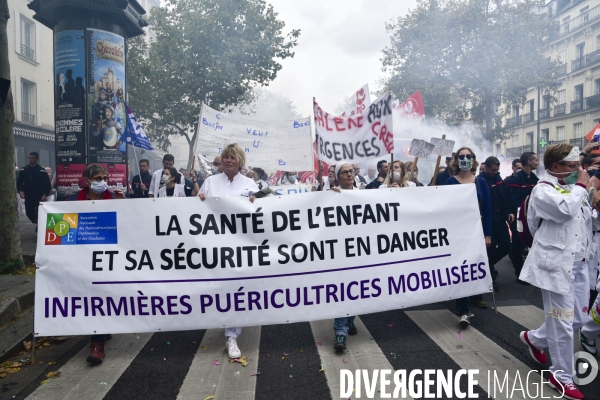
25;133;600;399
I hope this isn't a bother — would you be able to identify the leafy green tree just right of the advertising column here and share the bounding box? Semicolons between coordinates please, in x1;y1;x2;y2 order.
128;0;300;169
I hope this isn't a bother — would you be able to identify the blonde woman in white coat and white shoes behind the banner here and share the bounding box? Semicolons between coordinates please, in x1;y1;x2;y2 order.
198;143;259;358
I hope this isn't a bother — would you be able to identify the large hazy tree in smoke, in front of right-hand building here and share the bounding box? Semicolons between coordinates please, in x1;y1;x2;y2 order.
382;0;557;140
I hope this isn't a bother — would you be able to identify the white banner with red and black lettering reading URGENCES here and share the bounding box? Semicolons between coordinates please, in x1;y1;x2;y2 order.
314;92;394;164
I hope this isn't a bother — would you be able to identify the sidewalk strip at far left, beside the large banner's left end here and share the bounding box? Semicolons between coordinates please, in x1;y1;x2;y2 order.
0;216;37;361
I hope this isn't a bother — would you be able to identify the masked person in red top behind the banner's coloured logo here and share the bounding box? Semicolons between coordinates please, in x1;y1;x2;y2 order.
69;164;125;364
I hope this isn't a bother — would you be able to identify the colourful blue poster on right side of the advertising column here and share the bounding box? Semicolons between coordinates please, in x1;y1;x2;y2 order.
87;29;127;164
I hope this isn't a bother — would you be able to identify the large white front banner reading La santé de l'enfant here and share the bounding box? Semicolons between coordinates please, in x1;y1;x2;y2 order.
35;185;492;336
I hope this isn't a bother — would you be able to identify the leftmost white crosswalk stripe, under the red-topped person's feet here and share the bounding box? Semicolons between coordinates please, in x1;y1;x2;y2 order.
27;333;152;400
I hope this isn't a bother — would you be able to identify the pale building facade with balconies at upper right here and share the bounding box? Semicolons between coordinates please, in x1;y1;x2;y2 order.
494;0;600;160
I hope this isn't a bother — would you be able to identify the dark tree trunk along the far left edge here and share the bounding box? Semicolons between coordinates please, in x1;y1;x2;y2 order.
0;0;23;263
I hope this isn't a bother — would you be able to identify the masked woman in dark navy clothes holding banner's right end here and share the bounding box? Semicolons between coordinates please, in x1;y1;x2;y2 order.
446;147;492;329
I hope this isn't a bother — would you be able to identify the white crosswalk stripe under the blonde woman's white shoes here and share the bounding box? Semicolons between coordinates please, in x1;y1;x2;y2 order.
177;326;261;400
